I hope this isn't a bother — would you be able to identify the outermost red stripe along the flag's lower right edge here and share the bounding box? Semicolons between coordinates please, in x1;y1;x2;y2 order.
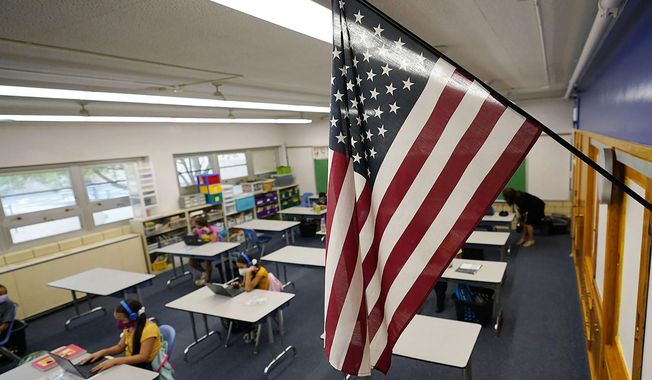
375;121;541;373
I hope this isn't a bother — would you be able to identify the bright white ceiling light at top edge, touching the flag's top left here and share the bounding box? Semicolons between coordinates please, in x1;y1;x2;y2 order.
211;0;333;44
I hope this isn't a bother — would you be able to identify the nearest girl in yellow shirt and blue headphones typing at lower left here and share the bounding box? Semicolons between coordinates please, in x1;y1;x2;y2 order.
81;299;162;372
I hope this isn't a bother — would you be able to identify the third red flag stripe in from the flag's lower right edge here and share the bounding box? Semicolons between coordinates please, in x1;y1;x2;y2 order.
362;71;471;288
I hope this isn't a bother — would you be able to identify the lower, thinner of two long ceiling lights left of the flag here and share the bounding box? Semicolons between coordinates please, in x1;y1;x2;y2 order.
0;115;312;124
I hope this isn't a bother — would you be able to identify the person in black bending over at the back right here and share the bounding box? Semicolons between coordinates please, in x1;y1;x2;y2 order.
503;187;546;248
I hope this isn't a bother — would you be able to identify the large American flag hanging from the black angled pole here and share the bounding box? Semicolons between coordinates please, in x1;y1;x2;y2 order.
324;0;540;376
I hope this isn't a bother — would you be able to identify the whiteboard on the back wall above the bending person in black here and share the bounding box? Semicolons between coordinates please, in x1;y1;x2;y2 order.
525;135;571;201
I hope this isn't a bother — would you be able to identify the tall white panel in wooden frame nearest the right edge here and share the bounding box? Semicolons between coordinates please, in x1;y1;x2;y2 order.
618;180;645;378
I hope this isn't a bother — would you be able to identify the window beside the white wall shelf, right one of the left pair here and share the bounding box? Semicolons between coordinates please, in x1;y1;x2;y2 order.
82;163;134;226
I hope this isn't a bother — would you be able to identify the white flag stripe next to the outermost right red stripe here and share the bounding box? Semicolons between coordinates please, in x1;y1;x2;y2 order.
371;109;525;359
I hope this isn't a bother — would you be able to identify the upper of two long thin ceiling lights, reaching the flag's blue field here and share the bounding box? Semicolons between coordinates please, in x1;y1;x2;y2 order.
0;85;330;113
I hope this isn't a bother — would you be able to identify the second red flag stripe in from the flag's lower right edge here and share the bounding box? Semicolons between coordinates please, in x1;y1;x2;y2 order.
369;98;505;339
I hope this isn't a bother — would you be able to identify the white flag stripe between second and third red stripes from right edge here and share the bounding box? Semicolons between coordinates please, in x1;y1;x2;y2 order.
367;82;489;320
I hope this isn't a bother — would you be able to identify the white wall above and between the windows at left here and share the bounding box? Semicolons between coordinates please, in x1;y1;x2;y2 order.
0;123;285;212
